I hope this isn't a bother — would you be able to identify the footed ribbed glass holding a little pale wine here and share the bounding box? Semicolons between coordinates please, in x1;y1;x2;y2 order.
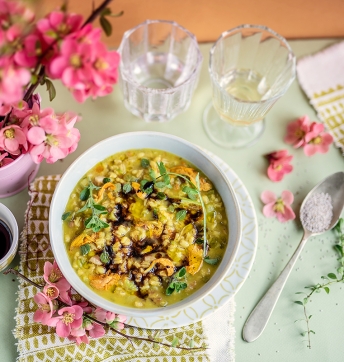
203;24;296;148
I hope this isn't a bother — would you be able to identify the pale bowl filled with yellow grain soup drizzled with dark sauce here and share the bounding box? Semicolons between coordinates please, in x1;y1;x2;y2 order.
49;132;241;316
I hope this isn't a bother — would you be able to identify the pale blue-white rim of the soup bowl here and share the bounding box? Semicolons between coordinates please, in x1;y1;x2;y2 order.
49;131;242;317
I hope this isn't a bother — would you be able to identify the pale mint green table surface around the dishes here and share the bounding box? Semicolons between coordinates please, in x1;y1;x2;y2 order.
0;40;344;362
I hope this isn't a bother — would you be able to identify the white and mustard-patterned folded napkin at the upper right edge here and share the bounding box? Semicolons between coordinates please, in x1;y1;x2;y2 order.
297;42;344;154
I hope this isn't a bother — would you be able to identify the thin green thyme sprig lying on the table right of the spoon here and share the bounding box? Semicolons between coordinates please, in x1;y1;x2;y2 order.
294;218;344;349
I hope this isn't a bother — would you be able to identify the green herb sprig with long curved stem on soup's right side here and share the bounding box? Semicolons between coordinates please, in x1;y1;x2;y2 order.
149;162;207;258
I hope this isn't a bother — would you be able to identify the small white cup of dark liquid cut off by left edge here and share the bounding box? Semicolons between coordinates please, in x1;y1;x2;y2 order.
0;204;19;271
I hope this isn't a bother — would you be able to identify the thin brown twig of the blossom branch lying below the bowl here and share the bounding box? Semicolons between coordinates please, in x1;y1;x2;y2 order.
4;268;207;351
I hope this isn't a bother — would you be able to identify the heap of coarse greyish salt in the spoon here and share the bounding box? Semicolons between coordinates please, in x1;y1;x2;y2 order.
300;192;333;233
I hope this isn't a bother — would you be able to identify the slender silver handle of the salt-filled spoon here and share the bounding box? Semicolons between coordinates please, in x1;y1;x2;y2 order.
243;233;310;342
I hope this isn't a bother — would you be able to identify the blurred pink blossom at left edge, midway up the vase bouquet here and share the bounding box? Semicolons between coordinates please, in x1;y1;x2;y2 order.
0;57;31;104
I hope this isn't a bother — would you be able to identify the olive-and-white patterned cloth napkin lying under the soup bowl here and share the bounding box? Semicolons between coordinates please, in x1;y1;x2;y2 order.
14;175;235;362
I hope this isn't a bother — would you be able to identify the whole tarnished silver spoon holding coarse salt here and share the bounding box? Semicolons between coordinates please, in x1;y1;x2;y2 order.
243;172;344;342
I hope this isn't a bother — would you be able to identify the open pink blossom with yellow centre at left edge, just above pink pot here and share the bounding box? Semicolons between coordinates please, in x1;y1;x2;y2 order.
0;125;28;155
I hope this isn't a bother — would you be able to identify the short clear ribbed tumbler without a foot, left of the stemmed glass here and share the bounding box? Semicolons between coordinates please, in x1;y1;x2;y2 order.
118;20;203;122
